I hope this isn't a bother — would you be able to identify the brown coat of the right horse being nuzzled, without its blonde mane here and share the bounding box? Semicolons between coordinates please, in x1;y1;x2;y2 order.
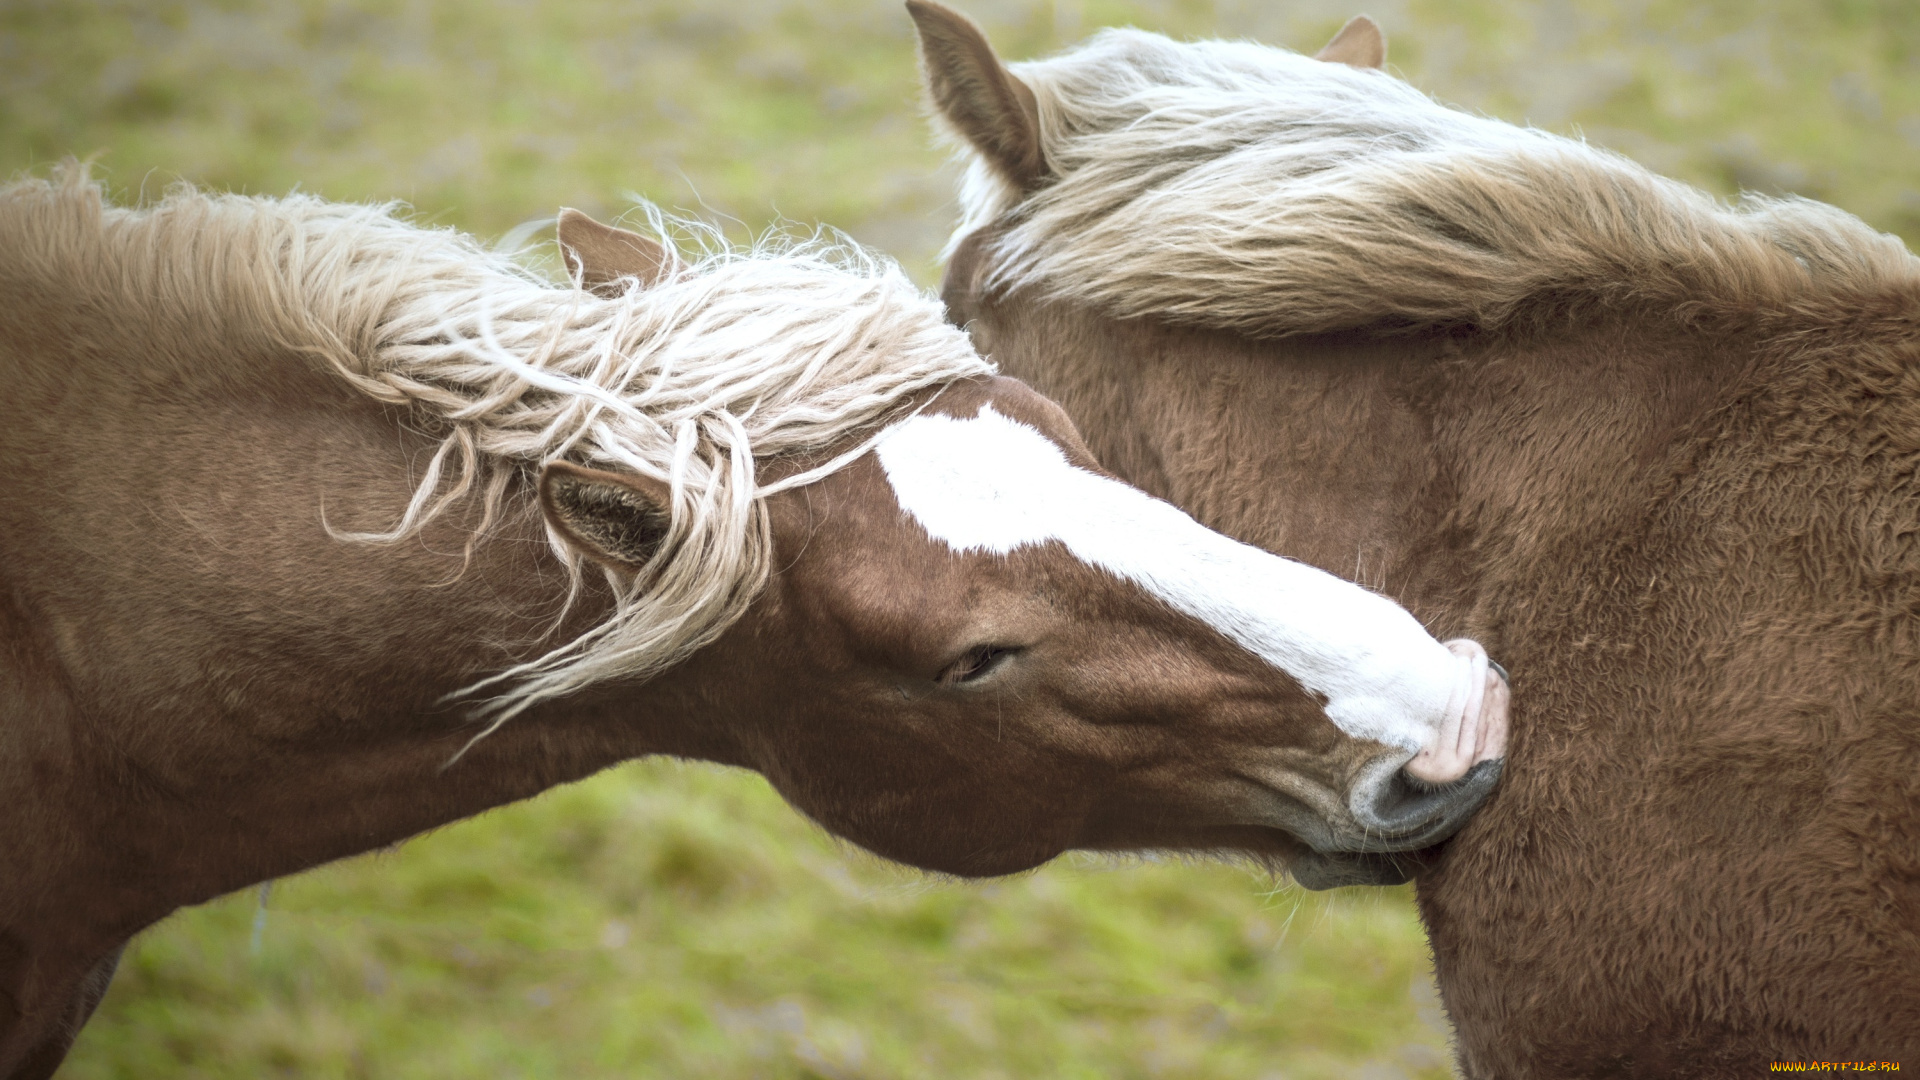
910;0;1920;1080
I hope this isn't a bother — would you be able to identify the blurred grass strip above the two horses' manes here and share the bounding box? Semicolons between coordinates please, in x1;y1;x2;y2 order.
0;0;1920;282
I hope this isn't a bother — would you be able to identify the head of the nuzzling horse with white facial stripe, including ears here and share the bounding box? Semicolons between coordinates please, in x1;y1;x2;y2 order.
540;210;1507;888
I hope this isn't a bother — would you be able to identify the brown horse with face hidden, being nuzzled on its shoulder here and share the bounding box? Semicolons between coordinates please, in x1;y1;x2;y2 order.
908;2;1920;1080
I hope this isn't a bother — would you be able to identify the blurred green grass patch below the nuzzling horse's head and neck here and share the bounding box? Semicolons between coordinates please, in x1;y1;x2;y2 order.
65;761;1446;1080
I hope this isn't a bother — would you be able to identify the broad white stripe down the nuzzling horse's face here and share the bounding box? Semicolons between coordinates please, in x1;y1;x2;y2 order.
876;405;1461;751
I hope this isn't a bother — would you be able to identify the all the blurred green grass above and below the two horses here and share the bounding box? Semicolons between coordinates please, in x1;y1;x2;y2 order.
0;0;1920;1080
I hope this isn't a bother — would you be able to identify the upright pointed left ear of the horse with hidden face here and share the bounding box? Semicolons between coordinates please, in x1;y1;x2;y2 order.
906;0;1046;190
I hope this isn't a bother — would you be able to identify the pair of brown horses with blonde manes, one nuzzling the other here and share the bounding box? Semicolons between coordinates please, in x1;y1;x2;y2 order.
0;2;1920;1078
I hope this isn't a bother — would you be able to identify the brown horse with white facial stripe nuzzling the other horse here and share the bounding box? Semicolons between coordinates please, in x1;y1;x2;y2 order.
0;169;1505;1078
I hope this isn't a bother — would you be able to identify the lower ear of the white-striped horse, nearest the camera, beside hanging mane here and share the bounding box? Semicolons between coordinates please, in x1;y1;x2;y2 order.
540;461;672;571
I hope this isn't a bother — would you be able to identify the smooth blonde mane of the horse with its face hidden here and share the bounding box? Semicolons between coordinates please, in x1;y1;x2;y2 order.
954;31;1920;336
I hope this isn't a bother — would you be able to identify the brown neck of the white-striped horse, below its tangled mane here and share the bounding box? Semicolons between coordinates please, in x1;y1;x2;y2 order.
0;319;728;949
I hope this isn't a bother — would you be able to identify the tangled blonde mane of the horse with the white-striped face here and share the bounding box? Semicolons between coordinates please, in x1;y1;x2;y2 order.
0;167;991;718
